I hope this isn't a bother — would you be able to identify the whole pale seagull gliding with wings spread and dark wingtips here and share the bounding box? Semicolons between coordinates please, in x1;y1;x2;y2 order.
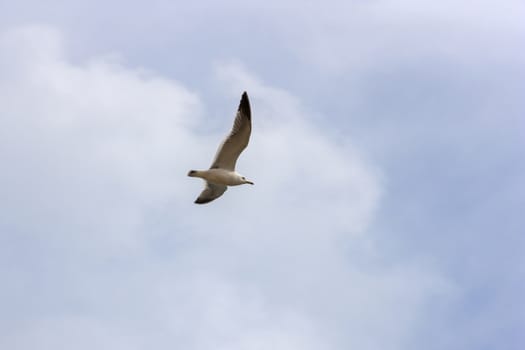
188;91;253;204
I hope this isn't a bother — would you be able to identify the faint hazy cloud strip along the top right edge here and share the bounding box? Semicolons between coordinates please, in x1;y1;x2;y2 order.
271;0;525;73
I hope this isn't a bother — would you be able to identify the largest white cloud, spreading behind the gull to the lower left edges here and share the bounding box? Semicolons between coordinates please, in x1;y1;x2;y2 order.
0;27;450;349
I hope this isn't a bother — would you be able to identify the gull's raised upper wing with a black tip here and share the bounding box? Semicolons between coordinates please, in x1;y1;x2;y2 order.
210;91;252;171
